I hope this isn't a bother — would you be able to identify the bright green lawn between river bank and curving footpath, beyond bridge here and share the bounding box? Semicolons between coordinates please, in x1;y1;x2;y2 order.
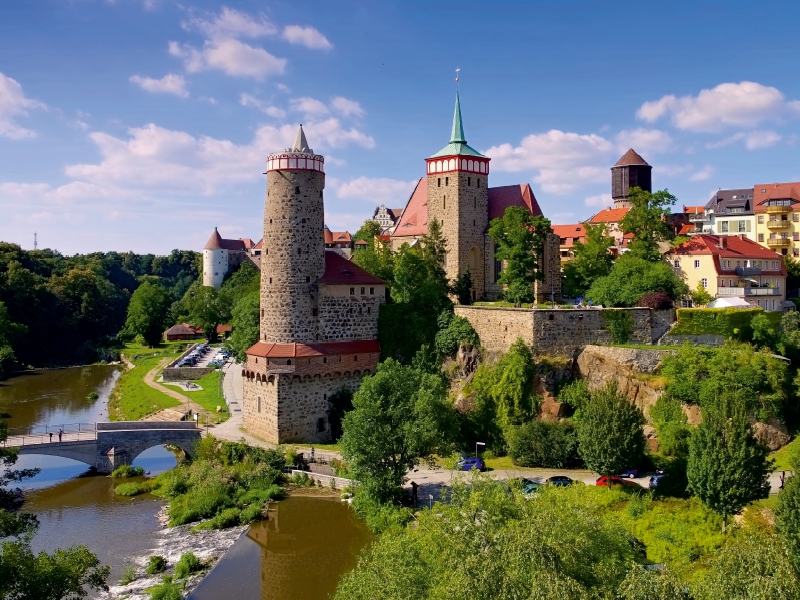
108;342;186;421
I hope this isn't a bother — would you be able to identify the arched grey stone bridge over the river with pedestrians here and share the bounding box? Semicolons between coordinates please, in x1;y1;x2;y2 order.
4;421;201;473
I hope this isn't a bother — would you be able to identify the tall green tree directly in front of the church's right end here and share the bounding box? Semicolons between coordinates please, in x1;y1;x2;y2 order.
489;206;552;304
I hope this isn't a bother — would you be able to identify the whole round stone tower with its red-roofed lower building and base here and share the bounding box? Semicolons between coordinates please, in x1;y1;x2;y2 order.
242;126;386;444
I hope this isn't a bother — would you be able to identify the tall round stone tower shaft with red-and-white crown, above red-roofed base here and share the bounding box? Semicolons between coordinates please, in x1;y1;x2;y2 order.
260;125;325;343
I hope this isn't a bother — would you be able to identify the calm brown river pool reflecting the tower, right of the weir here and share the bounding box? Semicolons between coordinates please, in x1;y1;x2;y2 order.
189;496;372;600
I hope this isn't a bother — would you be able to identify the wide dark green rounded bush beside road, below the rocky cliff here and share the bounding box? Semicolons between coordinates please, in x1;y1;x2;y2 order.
508;420;581;469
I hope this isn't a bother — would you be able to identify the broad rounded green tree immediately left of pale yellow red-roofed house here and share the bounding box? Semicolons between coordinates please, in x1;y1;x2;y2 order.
586;252;689;307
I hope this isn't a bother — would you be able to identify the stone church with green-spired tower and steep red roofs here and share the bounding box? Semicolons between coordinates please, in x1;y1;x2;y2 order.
391;93;561;301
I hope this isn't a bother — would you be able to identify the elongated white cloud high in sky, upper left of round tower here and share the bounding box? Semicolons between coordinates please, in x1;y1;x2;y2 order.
169;39;286;79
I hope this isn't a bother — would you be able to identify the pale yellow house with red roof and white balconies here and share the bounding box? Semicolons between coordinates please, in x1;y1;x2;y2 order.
665;233;786;311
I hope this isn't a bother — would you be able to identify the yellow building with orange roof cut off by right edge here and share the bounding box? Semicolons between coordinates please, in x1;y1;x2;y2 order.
753;182;800;258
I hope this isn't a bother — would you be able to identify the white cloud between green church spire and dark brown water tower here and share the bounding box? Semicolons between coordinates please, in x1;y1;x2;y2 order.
484;129;615;194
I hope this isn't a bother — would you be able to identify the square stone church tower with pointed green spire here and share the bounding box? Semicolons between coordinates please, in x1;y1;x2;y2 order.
425;92;490;298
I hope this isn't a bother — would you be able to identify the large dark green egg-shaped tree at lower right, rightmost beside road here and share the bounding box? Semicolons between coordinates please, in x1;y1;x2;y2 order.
686;401;772;530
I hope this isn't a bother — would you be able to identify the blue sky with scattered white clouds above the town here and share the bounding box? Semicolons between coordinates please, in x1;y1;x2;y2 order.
0;0;800;255
